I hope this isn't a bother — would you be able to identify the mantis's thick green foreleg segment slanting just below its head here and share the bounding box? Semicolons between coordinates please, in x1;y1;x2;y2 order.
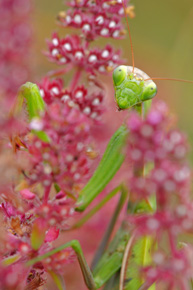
76;125;128;211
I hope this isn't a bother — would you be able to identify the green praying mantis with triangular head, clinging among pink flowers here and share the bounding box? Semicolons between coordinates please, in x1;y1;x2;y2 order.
10;1;193;290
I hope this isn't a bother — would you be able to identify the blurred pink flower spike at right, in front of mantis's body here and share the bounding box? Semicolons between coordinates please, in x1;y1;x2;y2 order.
128;102;193;290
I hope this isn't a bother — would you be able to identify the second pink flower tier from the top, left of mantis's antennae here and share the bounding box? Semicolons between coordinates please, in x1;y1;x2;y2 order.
46;33;120;74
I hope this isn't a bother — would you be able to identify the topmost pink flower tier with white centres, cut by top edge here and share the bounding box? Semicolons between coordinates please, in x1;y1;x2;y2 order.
58;0;128;41
